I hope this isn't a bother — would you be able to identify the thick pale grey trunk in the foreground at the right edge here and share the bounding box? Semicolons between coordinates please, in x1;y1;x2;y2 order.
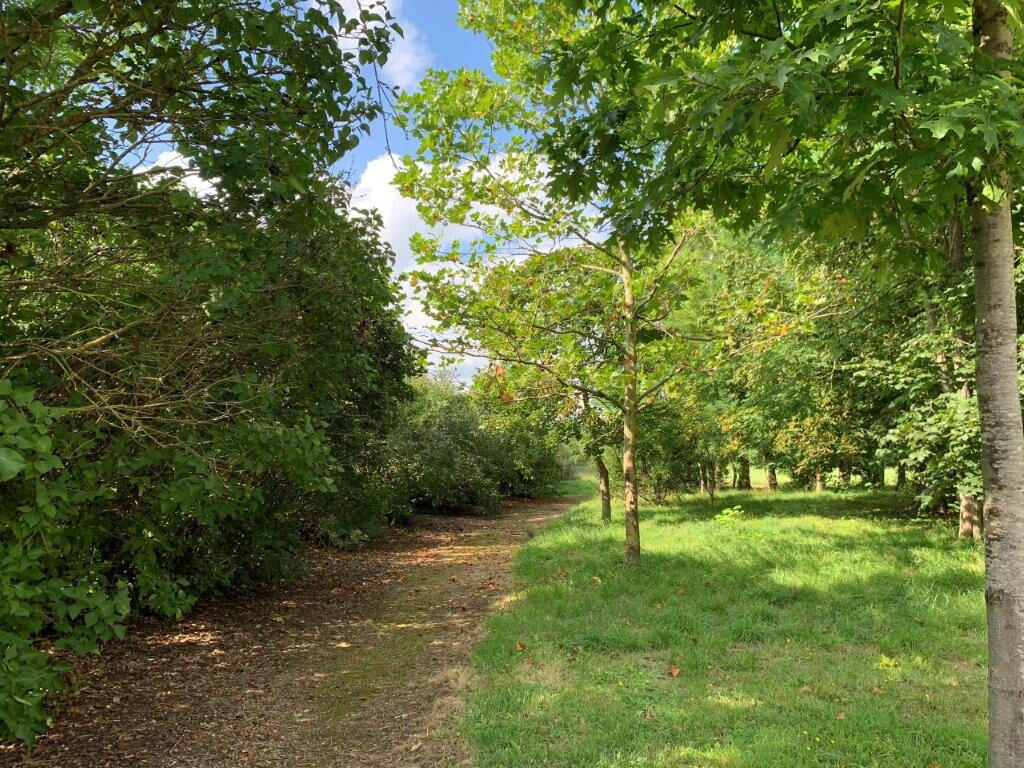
971;0;1024;768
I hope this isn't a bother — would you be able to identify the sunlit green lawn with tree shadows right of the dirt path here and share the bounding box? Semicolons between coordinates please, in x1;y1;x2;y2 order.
463;493;986;768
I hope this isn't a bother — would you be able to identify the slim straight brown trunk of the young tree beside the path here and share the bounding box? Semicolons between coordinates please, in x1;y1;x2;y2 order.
622;250;640;565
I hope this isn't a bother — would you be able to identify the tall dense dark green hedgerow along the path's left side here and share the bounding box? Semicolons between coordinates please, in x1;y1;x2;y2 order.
0;0;416;740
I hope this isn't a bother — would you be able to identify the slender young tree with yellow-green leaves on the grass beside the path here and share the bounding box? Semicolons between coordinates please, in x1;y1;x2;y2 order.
397;65;712;562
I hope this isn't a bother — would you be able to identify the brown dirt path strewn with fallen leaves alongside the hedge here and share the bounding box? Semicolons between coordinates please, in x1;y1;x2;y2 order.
0;501;571;768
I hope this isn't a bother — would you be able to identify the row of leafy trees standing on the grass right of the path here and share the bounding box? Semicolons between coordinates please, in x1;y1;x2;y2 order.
400;0;1024;768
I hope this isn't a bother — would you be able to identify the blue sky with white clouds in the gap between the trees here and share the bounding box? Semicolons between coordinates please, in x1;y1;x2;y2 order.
337;0;490;380
